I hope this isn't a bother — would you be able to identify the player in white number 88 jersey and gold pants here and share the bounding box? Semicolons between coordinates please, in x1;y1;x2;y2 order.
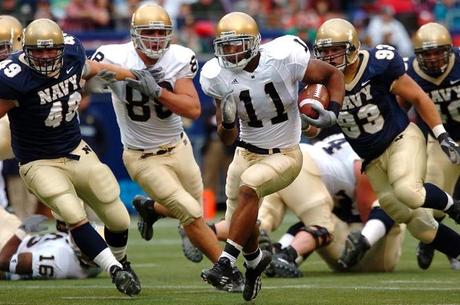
85;4;246;290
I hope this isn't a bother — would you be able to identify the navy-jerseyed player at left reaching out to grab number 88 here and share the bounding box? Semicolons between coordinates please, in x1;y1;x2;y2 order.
0;19;146;295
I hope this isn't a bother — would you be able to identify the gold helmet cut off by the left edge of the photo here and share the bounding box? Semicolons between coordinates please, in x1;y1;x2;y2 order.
0;15;22;60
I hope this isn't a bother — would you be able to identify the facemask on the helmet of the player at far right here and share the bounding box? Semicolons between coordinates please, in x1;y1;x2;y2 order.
415;45;452;77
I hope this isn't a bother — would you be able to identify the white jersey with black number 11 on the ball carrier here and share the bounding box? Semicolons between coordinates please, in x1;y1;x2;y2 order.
200;35;310;148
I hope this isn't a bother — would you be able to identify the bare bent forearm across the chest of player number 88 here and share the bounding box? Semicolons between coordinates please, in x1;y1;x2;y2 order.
159;89;201;120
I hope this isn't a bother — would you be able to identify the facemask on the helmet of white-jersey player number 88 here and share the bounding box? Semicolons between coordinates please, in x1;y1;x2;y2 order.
131;22;172;59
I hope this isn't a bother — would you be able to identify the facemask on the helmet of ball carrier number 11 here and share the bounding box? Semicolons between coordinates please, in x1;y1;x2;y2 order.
214;33;260;72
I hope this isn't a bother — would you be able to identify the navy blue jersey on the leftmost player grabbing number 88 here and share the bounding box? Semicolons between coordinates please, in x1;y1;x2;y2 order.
0;36;86;163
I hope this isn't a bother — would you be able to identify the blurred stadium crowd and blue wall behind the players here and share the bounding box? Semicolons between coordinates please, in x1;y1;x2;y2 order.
0;0;460;211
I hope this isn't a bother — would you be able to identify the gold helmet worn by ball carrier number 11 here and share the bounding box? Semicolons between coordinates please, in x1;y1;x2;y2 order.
214;12;260;72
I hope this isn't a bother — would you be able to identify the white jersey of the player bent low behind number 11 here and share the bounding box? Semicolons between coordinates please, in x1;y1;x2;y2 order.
300;133;360;215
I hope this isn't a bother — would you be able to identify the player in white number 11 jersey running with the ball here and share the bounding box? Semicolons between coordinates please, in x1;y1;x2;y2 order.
200;12;344;301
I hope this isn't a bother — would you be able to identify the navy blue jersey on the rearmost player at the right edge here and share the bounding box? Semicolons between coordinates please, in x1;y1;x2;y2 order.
407;48;460;141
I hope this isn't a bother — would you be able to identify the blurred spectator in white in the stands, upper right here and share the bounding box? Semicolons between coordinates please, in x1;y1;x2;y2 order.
367;6;413;56
